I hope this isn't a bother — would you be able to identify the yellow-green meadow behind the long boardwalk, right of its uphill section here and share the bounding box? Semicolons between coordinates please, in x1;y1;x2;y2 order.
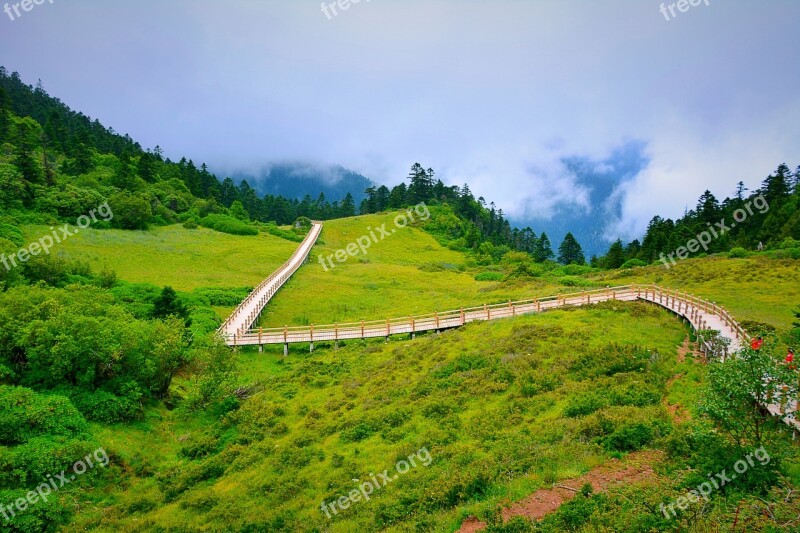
262;213;800;328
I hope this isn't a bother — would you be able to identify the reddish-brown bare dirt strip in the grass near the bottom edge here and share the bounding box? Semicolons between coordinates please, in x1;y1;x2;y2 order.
458;451;663;533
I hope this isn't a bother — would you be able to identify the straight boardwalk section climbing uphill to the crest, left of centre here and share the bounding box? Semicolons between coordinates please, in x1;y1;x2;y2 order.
218;222;322;340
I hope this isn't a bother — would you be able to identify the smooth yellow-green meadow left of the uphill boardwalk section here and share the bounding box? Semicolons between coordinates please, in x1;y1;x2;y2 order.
22;226;297;291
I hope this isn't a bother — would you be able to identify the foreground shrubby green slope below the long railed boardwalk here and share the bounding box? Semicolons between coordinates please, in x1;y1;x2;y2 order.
69;304;696;532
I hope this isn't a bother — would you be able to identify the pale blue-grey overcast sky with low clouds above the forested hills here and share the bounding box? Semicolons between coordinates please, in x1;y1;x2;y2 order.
0;0;800;238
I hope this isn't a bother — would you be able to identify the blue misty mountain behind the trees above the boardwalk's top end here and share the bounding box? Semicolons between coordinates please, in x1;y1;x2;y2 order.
231;163;374;205
